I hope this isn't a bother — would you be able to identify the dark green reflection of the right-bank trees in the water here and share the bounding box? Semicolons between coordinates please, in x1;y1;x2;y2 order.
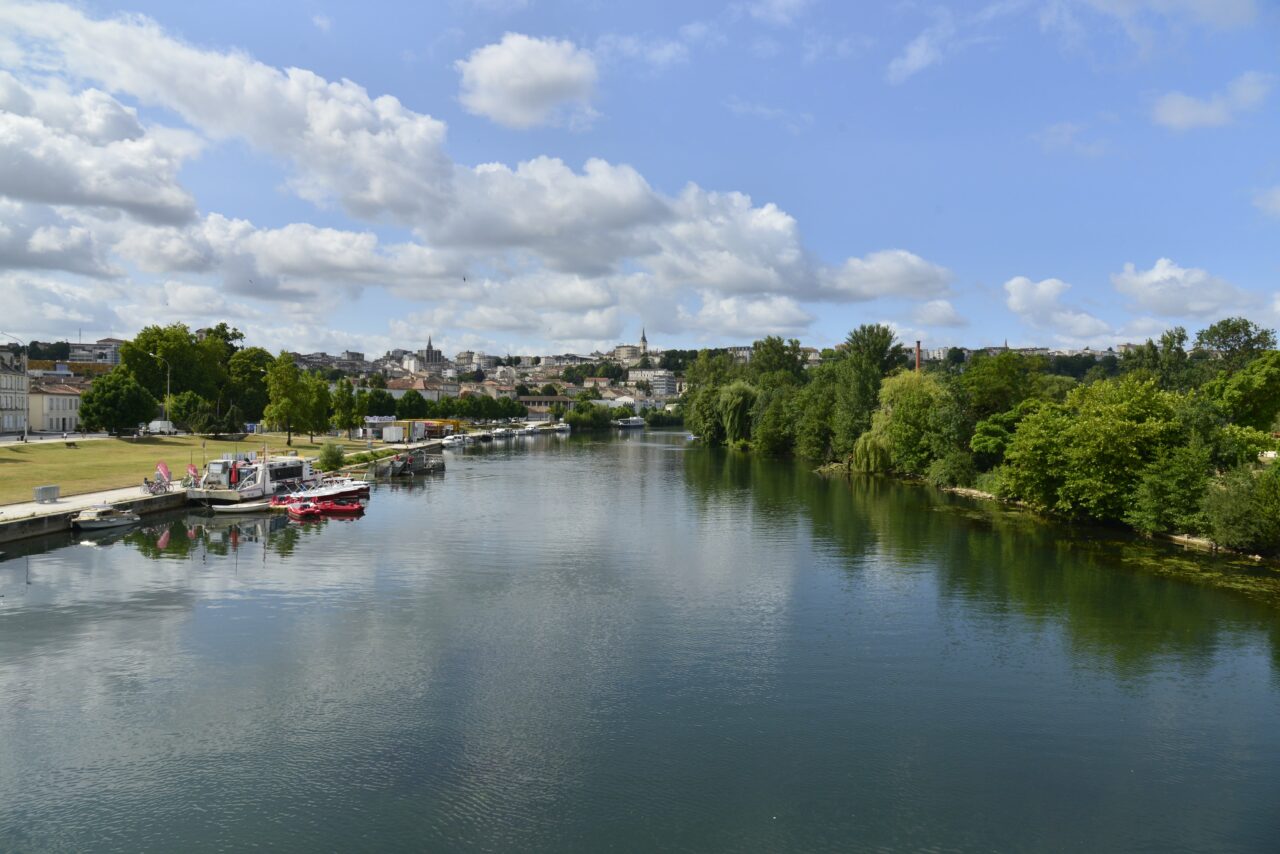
685;449;1280;677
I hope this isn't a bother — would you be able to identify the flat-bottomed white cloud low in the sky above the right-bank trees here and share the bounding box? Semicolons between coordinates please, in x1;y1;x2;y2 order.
1111;257;1257;318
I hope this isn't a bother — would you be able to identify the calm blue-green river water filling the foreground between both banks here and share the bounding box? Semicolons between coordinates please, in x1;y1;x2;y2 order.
0;433;1280;851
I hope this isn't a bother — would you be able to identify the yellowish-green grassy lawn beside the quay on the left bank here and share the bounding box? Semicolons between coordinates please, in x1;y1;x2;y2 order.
0;433;378;504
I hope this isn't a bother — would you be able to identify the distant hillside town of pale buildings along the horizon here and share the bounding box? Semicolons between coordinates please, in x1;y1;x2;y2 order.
0;324;1138;435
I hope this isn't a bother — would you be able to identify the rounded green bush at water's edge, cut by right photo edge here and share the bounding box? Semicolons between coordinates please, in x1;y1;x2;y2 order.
1203;465;1280;554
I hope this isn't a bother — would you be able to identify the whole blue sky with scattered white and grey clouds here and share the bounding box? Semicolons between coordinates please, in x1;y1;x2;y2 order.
0;0;1280;352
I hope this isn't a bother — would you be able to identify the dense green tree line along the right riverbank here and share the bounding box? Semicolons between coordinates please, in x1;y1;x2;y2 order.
685;318;1280;553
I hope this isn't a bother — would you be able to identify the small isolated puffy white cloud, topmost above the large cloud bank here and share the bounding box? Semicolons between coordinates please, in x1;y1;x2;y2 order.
456;33;596;128
